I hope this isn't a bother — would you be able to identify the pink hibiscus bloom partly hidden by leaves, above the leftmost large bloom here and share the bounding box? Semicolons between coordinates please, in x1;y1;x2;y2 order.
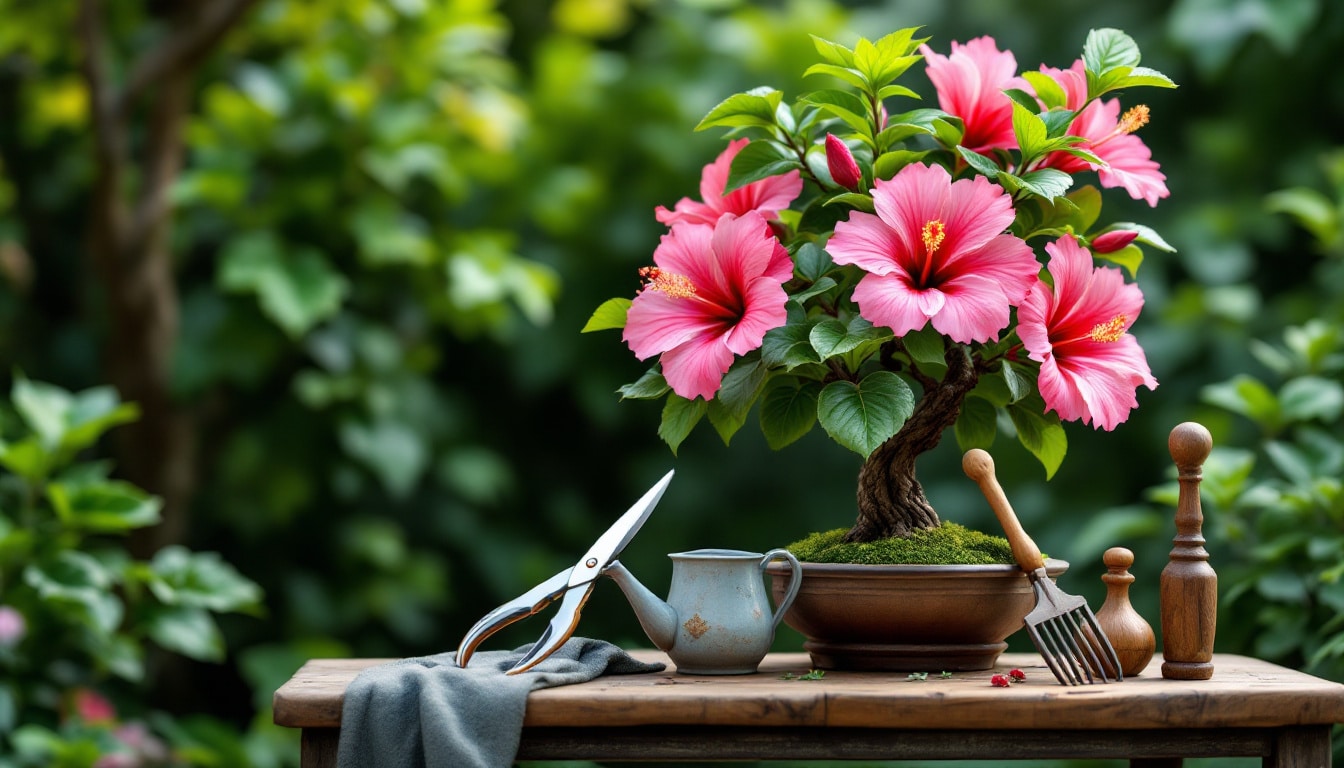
653;139;802;226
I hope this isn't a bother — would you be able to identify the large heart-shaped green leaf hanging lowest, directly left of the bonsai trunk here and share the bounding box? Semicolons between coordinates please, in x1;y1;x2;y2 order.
817;371;915;457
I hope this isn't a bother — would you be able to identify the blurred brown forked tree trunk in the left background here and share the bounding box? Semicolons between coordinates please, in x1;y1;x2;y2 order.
78;0;255;557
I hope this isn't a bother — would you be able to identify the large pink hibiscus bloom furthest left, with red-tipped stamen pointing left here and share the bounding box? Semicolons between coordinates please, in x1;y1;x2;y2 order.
624;211;793;399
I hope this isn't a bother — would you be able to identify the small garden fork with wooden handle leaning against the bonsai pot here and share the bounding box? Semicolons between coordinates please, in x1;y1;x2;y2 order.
961;448;1124;686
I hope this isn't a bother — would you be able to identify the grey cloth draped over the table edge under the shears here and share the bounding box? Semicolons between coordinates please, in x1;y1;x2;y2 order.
336;638;665;768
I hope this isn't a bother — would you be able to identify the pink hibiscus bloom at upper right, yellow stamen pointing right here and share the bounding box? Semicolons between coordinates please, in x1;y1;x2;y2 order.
1040;59;1171;206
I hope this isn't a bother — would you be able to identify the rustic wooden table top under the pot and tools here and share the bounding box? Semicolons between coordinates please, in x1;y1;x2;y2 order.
274;651;1344;730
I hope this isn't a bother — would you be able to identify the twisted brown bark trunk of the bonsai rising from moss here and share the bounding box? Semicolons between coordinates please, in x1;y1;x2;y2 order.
844;344;980;542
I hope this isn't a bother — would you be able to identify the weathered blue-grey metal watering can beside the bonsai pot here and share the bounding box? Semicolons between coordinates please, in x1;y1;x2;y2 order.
605;549;802;675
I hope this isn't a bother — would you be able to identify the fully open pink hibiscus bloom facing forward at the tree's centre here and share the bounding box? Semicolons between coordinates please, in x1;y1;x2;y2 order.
827;164;1040;343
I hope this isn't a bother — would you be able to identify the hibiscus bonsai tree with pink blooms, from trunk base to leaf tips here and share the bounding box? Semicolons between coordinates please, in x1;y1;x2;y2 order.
585;28;1175;542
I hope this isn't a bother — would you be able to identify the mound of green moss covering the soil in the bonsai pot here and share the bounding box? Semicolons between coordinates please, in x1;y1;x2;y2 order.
788;522;1016;565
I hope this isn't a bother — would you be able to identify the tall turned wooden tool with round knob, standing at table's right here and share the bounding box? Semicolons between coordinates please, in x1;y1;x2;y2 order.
1161;421;1218;681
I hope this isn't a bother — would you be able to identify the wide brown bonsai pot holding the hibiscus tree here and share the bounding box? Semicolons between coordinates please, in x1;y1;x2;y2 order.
766;558;1068;673
